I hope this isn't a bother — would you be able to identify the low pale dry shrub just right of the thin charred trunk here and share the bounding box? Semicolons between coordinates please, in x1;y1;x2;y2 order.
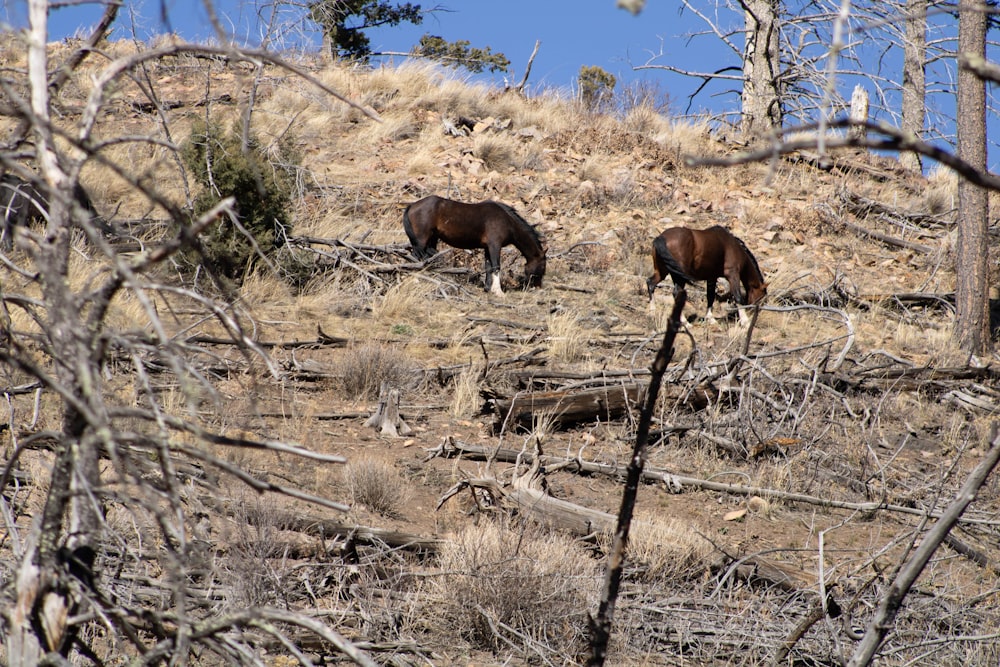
600;511;715;590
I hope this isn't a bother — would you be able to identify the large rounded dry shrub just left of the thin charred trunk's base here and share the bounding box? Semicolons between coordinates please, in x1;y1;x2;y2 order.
421;521;600;662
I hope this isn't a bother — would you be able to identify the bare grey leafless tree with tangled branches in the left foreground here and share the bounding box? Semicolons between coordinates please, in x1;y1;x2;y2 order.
0;0;374;665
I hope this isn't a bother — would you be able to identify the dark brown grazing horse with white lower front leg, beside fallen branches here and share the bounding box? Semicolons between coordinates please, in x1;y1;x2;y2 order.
403;195;545;296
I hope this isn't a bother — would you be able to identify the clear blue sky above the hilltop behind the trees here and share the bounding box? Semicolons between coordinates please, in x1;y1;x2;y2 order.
0;0;1000;170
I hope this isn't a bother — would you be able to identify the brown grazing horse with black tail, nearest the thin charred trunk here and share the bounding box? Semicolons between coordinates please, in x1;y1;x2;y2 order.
646;225;767;325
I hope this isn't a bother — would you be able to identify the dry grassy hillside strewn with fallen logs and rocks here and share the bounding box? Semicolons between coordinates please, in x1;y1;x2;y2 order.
0;39;1000;665
